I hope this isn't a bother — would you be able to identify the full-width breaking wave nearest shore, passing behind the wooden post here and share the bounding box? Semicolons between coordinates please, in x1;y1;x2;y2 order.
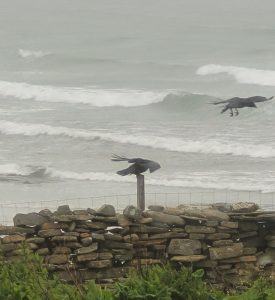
0;164;275;193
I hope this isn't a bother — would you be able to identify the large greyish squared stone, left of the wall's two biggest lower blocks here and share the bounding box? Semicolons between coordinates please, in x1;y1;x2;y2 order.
167;239;201;255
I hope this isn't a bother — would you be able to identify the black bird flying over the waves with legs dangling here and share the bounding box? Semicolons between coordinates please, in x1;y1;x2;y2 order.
212;96;274;117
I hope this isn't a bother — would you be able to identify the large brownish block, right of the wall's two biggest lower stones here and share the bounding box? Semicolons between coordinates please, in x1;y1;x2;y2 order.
209;243;243;260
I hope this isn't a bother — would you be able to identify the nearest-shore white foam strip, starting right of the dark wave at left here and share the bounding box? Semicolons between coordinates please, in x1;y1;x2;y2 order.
47;169;275;193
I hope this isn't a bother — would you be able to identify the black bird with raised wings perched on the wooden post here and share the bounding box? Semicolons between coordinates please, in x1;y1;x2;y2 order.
111;155;160;176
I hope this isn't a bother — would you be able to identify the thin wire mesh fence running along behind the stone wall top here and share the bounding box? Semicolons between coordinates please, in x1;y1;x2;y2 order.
0;190;275;225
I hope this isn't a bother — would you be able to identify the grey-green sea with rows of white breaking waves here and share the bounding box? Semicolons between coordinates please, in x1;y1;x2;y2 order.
0;0;275;223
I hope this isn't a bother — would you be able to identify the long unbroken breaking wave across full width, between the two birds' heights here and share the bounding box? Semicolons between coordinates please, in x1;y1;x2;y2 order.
0;121;275;158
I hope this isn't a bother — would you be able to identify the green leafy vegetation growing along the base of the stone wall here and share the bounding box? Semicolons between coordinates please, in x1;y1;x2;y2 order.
0;247;275;300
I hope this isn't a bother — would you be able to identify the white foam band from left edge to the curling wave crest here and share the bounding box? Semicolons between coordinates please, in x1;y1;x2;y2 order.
0;81;167;107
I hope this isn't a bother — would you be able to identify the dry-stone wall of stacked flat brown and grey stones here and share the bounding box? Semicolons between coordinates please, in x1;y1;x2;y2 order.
0;203;275;285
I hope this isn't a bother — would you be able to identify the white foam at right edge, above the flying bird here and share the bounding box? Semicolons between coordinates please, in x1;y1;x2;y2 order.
197;64;275;86
